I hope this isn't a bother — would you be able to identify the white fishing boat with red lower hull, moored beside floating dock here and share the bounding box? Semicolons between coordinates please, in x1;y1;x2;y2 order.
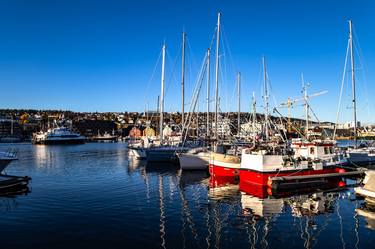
239;139;347;185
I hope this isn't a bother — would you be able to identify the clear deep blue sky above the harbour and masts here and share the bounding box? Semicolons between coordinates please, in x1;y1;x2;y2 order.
0;0;375;122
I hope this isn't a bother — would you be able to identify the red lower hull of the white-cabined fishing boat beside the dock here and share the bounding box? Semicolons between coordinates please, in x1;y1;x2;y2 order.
240;167;342;186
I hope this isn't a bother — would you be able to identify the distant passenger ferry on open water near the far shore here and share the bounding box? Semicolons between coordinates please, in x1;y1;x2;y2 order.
32;127;86;144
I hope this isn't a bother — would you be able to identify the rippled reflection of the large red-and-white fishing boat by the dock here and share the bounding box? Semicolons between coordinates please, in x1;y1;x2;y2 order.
240;181;352;248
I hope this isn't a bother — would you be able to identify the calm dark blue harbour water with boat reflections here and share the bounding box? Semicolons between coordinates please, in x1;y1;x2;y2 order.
0;143;375;248
